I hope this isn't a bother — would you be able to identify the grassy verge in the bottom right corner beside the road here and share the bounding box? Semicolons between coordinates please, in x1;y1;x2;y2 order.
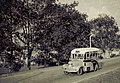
79;69;120;83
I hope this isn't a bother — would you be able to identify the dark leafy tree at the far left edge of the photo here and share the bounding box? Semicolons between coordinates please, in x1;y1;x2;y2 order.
0;0;25;70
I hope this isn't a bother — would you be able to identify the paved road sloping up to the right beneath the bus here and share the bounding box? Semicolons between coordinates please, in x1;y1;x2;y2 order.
0;57;120;83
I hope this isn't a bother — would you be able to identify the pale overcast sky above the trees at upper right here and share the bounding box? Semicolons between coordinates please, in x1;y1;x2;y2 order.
59;0;120;27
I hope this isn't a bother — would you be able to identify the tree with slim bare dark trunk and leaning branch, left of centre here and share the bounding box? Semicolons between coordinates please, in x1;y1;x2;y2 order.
13;0;57;69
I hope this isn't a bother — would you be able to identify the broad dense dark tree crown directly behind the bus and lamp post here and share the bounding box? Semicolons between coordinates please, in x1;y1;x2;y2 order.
34;2;90;61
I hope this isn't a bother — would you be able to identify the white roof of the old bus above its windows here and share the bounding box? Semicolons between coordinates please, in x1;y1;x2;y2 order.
71;47;100;54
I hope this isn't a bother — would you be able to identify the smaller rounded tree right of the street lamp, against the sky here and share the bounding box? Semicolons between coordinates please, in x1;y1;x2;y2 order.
90;14;119;49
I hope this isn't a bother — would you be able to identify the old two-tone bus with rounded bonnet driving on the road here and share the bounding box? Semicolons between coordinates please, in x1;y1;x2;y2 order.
63;47;102;75
